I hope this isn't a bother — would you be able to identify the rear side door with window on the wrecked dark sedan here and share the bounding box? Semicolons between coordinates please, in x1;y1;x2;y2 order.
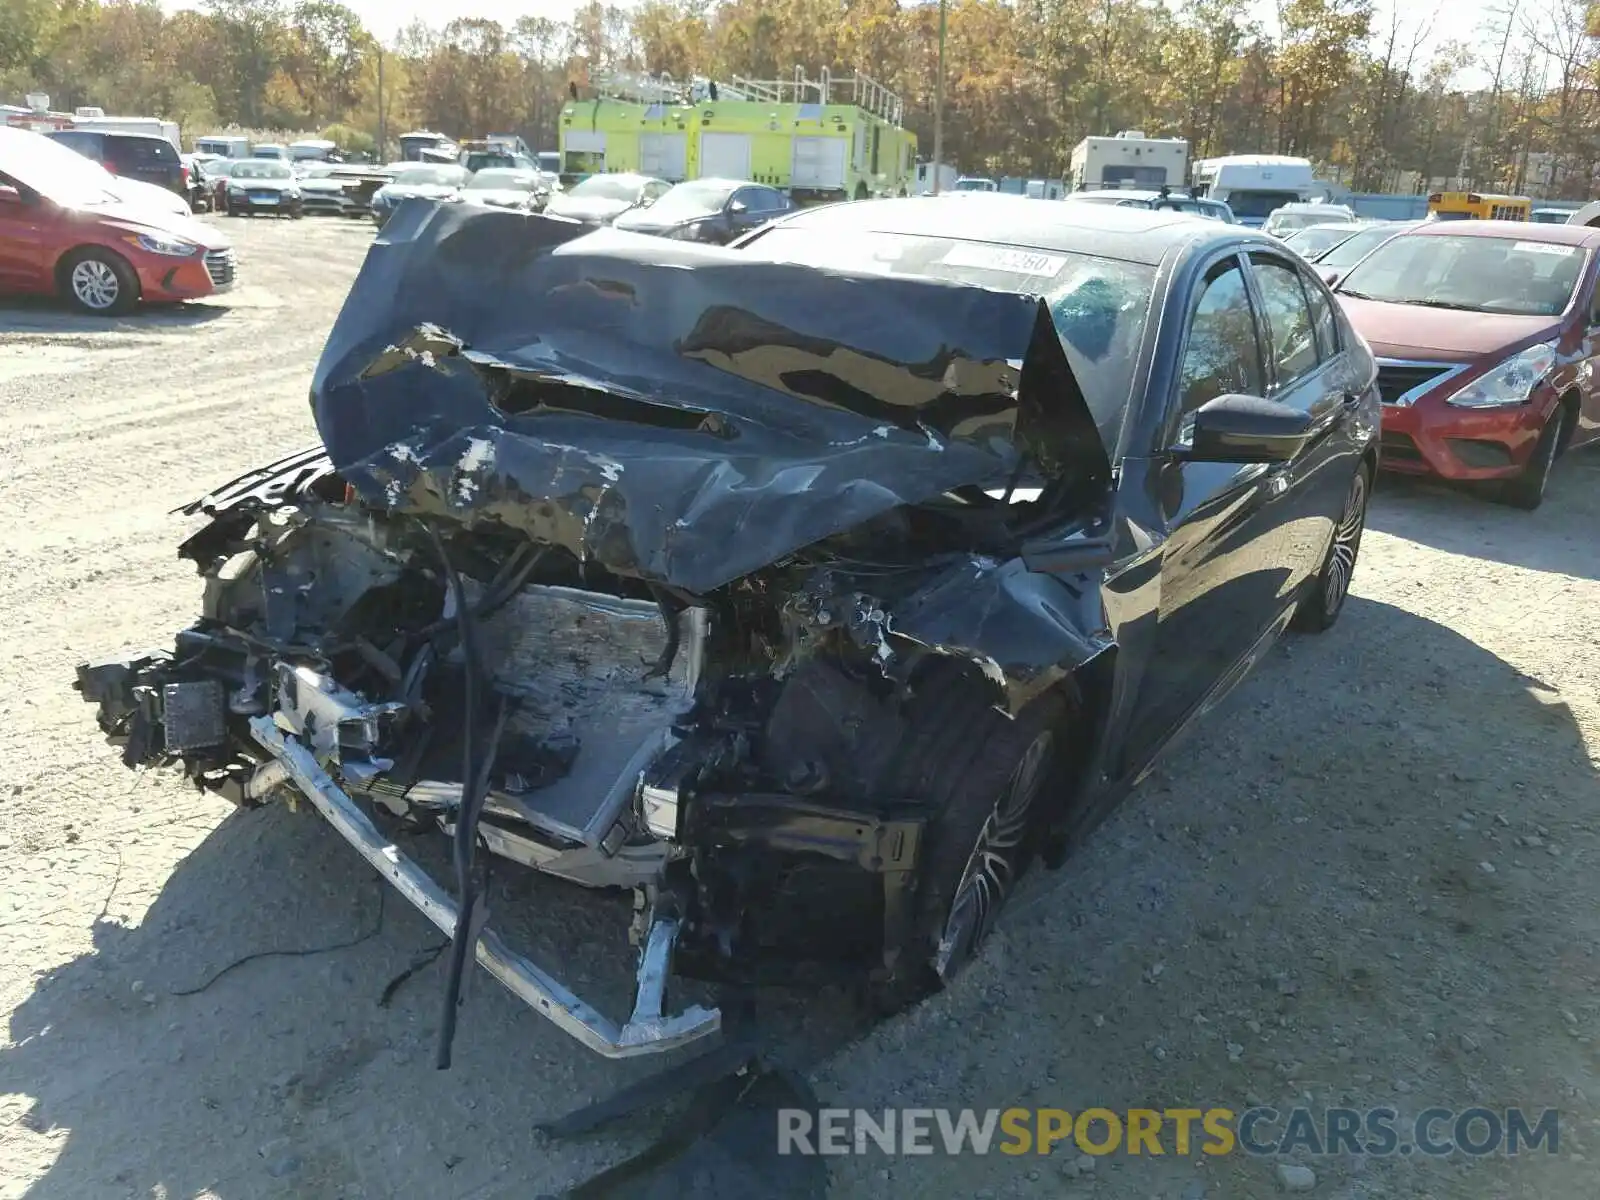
1248;250;1360;603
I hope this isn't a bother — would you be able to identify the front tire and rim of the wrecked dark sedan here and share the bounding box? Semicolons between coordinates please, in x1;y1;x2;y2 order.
872;664;1066;1013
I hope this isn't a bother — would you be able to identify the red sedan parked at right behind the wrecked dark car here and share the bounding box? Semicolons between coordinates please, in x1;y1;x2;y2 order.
1334;221;1600;509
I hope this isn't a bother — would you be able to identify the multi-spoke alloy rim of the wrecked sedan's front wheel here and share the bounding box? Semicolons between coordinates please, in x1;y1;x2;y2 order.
933;731;1054;979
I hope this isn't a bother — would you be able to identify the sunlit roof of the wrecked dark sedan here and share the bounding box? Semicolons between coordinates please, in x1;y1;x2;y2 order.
776;192;1228;266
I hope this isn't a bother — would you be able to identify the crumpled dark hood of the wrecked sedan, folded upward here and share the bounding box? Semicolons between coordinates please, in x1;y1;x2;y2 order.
312;205;1110;592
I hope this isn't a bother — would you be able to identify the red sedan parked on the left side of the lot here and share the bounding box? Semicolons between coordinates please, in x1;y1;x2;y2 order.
0;128;234;315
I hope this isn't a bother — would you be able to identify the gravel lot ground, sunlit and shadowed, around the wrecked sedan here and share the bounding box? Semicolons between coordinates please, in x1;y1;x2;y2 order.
0;221;1600;1200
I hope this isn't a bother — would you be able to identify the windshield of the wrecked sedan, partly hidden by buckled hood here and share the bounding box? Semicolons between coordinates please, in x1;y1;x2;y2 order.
746;224;1155;446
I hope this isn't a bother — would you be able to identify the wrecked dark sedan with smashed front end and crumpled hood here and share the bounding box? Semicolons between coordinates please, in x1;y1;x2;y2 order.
78;197;1379;1056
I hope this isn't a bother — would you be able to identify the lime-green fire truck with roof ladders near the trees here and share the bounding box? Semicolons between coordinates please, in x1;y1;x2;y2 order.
560;67;917;203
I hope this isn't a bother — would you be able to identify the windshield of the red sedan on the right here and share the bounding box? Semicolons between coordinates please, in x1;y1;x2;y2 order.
1339;234;1584;317
